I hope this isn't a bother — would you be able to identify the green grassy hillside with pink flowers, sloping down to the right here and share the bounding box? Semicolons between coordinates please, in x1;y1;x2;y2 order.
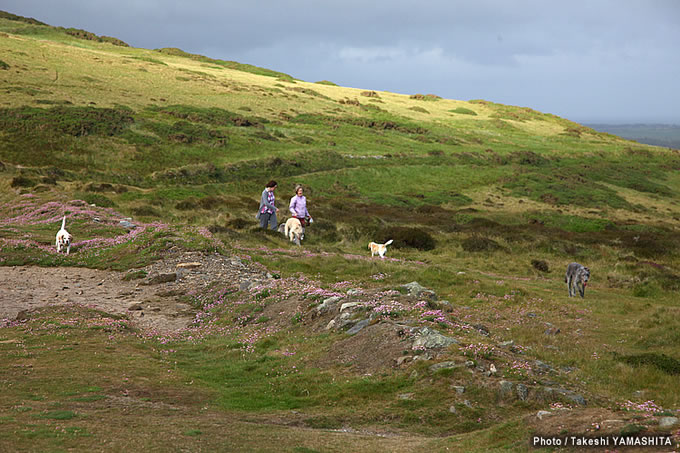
0;14;680;451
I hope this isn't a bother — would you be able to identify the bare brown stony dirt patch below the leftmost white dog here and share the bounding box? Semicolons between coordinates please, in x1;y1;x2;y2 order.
0;253;274;333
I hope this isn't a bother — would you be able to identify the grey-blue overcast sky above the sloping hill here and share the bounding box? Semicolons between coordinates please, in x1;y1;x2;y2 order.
0;0;680;124
